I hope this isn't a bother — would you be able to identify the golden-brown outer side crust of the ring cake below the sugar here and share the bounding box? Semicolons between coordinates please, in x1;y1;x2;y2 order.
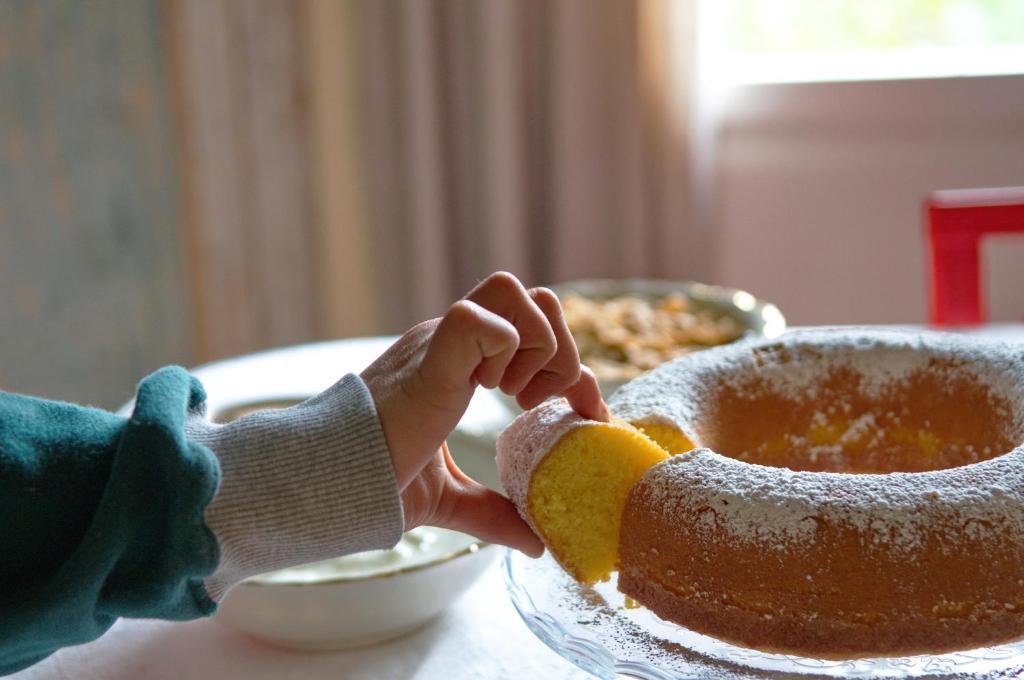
618;452;1024;657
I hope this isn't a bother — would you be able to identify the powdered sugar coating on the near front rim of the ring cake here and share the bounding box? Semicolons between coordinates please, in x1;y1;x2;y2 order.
639;448;1024;553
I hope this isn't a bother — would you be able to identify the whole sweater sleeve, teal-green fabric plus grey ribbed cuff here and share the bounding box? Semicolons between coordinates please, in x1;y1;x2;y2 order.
0;367;403;675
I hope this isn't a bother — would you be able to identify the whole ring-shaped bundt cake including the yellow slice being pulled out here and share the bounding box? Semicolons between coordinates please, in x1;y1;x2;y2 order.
498;330;1024;658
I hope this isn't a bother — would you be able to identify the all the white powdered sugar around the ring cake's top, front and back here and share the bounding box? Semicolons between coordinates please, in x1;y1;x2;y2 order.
610;330;1024;558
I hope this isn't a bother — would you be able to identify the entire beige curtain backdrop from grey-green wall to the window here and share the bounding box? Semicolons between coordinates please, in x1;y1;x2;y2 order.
172;0;711;350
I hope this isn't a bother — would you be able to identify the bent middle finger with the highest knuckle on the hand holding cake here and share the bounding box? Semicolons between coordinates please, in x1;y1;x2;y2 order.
466;271;557;394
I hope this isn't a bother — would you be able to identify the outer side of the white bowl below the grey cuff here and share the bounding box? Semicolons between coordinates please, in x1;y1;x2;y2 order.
215;532;498;650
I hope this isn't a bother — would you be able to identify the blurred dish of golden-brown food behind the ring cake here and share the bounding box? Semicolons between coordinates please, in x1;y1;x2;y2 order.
551;279;785;396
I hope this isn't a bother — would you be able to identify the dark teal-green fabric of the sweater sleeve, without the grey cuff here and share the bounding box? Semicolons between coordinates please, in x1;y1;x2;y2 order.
0;367;219;675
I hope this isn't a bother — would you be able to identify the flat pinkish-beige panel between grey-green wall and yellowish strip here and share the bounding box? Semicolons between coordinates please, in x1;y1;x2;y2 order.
173;0;322;362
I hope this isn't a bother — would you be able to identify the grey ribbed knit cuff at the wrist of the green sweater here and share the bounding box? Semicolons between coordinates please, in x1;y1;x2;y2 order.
185;375;403;601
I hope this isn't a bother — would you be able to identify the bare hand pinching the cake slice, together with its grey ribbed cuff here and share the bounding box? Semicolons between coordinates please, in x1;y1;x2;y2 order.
187;273;607;600
